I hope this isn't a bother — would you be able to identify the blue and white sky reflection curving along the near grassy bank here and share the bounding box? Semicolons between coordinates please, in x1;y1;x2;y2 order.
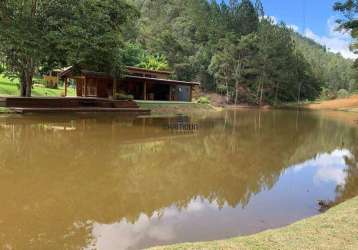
84;150;353;250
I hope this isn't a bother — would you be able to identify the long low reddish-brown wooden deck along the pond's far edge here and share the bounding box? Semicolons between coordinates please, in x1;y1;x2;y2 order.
0;97;150;115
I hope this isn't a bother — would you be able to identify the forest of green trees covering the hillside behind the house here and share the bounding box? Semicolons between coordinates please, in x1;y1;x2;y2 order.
0;0;358;105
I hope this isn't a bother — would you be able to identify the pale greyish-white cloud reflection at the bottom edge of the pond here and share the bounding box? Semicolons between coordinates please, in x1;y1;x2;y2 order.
85;198;220;250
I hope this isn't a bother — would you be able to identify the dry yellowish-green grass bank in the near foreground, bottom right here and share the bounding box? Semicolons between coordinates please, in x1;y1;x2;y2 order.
153;197;358;250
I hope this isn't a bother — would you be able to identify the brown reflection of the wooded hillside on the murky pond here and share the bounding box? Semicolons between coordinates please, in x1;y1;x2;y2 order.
0;112;357;248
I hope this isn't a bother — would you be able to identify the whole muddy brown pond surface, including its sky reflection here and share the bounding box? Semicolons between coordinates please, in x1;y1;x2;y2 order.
0;110;358;250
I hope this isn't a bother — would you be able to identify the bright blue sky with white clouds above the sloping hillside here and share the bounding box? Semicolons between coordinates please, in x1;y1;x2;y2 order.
261;0;358;58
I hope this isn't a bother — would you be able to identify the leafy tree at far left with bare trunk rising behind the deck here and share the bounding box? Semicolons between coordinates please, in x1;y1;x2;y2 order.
0;0;48;96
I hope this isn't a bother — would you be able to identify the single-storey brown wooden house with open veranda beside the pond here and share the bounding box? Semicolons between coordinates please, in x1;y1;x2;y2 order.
59;67;200;102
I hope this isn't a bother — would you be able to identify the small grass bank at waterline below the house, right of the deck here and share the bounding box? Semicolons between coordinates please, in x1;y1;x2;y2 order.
137;101;220;115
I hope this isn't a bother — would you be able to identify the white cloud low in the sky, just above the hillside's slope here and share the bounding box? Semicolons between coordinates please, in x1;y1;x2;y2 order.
303;17;358;59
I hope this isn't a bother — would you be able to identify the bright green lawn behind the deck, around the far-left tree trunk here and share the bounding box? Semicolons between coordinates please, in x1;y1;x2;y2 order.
0;75;75;96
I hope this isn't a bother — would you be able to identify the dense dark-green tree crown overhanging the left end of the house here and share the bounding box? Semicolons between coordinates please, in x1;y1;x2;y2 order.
43;0;138;78
